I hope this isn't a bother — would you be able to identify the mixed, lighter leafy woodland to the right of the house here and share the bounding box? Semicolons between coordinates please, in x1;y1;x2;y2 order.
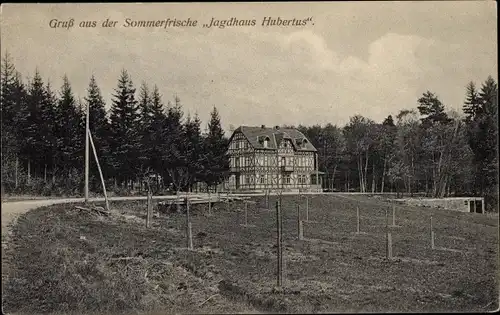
290;76;498;210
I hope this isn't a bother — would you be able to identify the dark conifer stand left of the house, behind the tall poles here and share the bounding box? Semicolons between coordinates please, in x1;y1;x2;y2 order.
1;54;229;195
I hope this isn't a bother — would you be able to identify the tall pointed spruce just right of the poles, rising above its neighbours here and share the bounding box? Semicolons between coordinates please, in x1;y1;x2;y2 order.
110;70;140;188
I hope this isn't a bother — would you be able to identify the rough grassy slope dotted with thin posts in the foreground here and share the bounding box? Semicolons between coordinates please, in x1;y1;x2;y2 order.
3;195;499;314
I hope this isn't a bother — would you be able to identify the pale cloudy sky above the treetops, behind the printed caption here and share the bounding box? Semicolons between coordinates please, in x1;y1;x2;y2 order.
1;1;498;135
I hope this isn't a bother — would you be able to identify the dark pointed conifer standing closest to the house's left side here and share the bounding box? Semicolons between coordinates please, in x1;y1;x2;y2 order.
204;106;229;190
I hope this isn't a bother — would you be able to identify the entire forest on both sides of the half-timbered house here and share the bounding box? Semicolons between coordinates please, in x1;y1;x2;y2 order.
1;54;498;211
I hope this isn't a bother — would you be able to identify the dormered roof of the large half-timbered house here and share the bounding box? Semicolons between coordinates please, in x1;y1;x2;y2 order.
230;126;317;152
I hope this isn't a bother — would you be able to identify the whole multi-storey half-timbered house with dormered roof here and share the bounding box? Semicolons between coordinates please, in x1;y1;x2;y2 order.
225;126;321;191
